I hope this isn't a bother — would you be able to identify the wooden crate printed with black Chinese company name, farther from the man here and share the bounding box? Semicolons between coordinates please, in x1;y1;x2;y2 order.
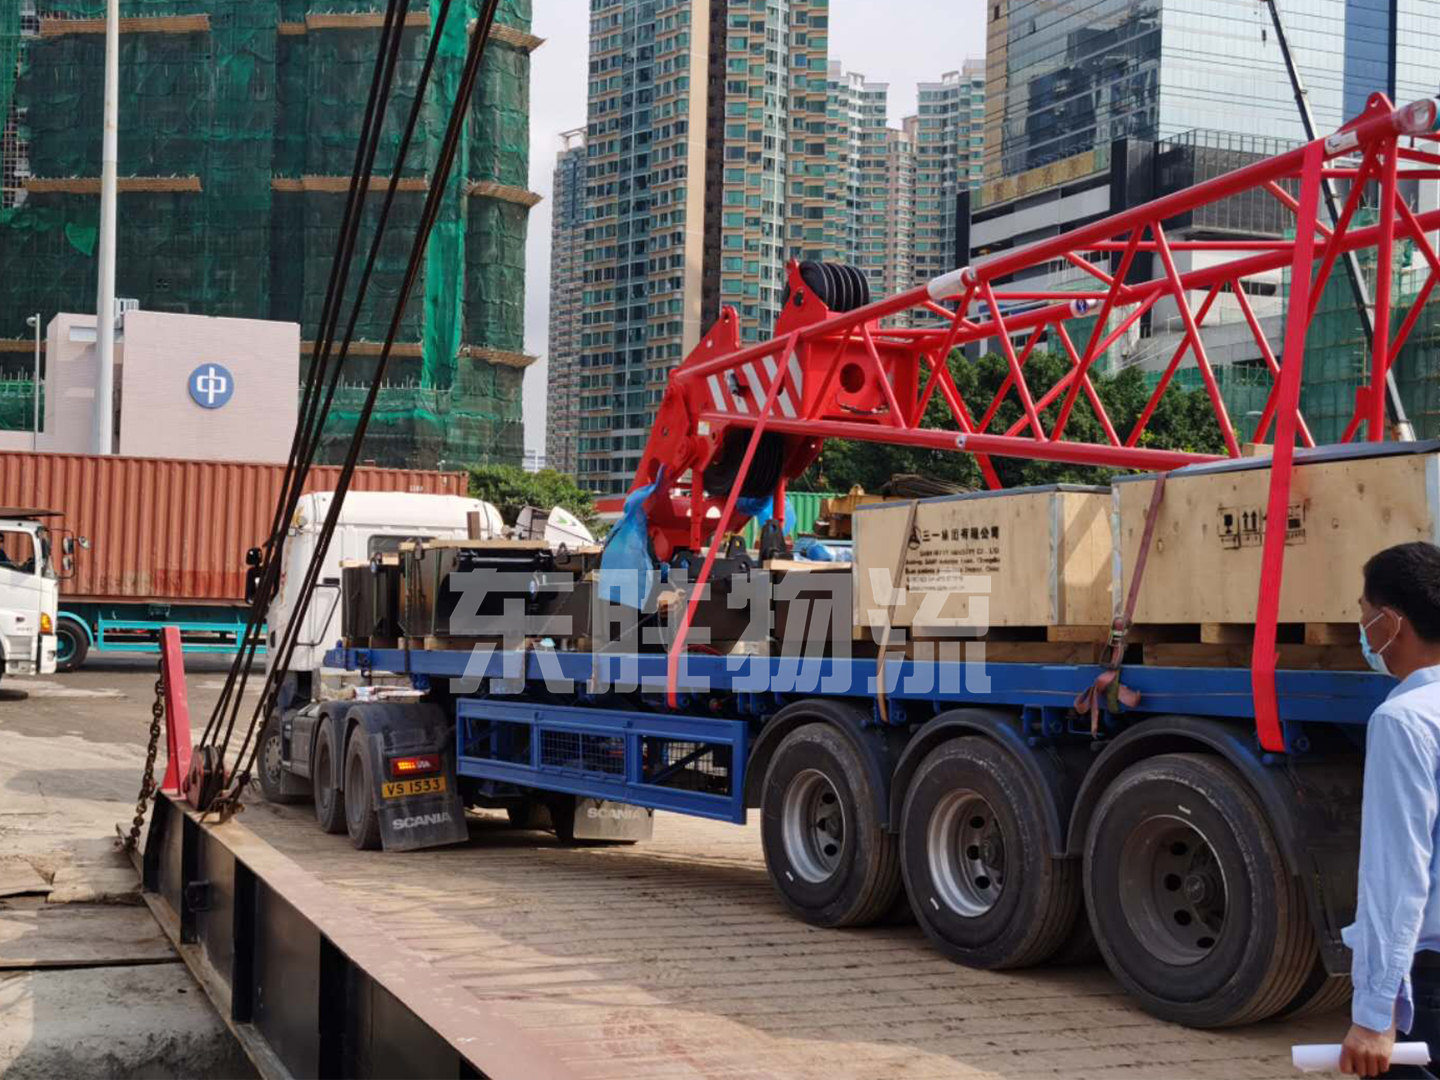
855;485;1113;634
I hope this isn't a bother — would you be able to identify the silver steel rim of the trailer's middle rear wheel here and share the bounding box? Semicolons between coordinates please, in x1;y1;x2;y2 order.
924;791;1005;919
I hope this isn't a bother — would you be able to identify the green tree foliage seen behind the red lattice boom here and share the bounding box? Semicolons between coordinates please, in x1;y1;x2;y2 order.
792;351;1225;491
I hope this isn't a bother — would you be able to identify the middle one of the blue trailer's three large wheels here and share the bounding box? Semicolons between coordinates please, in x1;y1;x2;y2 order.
900;736;1081;969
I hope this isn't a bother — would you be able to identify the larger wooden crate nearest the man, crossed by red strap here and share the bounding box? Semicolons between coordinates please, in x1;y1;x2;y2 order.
1113;444;1440;624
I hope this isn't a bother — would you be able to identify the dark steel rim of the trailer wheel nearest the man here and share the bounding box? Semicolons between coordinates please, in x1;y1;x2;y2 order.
1120;814;1230;968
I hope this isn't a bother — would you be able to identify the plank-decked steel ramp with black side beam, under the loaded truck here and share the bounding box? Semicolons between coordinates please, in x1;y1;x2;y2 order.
145;796;1344;1080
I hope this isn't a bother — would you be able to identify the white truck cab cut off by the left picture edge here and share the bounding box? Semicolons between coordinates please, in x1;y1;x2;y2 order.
0;507;75;675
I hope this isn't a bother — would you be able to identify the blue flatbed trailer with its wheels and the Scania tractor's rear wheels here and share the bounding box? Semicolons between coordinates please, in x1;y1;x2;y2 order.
244;648;1392;1027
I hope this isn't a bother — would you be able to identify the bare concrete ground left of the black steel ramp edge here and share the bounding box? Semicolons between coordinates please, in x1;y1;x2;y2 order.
0;657;253;1080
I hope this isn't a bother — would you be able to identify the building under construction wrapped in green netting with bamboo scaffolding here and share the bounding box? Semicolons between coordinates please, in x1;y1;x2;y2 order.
0;0;540;468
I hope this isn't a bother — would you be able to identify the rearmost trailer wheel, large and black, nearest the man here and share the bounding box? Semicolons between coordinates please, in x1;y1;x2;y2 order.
1084;753;1315;1028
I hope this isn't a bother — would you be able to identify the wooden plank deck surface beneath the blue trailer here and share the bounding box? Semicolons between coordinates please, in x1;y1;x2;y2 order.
242;799;1346;1080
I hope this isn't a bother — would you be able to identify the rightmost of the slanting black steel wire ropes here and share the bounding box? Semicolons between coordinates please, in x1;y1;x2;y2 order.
217;0;498;806
